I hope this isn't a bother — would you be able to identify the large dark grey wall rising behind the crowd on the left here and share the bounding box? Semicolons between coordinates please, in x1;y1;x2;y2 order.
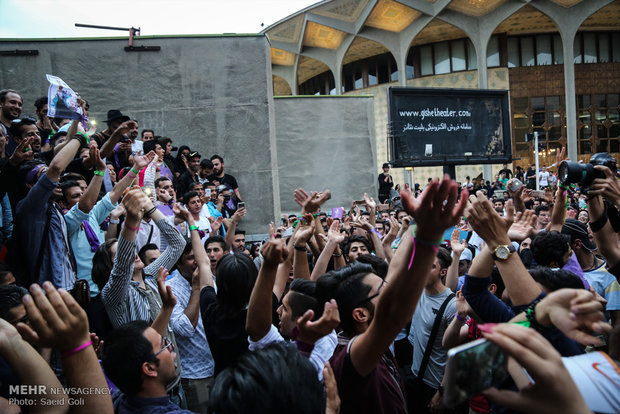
0;35;280;233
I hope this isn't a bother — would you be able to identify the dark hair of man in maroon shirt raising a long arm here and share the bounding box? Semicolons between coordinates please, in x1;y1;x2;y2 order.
316;262;374;335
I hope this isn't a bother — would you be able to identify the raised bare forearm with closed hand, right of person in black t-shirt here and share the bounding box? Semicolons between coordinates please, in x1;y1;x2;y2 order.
245;240;288;342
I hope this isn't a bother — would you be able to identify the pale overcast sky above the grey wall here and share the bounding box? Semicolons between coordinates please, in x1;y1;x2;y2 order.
0;0;318;39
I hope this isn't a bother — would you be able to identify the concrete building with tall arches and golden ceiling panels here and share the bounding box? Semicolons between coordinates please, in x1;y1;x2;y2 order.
264;0;620;183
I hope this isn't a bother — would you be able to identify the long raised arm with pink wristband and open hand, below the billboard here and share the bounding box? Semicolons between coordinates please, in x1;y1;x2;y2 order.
351;175;467;376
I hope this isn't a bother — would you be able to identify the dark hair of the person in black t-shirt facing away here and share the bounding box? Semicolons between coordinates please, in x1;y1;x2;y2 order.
215;253;258;318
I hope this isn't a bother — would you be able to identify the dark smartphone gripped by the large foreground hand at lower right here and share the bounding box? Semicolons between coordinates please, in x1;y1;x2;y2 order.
443;338;508;408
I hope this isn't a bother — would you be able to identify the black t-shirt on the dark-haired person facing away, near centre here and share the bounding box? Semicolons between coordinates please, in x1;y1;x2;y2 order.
200;286;278;375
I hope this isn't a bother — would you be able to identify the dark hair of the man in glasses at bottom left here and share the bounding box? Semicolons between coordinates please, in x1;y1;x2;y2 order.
101;321;159;397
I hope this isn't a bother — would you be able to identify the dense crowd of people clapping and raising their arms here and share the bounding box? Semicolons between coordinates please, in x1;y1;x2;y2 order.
0;89;620;414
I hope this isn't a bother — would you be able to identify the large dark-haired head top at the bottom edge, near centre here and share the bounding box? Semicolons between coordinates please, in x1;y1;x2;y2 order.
209;342;325;414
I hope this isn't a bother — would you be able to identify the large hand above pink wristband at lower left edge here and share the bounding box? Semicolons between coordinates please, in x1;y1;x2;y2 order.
17;282;90;352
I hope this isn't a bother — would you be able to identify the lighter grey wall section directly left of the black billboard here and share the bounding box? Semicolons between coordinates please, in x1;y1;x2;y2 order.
275;96;377;212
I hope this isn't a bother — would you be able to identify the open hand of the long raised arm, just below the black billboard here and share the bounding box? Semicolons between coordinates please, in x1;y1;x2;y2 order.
400;174;469;241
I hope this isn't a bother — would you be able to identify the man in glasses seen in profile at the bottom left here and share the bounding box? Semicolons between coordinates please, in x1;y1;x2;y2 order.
102;321;191;413
